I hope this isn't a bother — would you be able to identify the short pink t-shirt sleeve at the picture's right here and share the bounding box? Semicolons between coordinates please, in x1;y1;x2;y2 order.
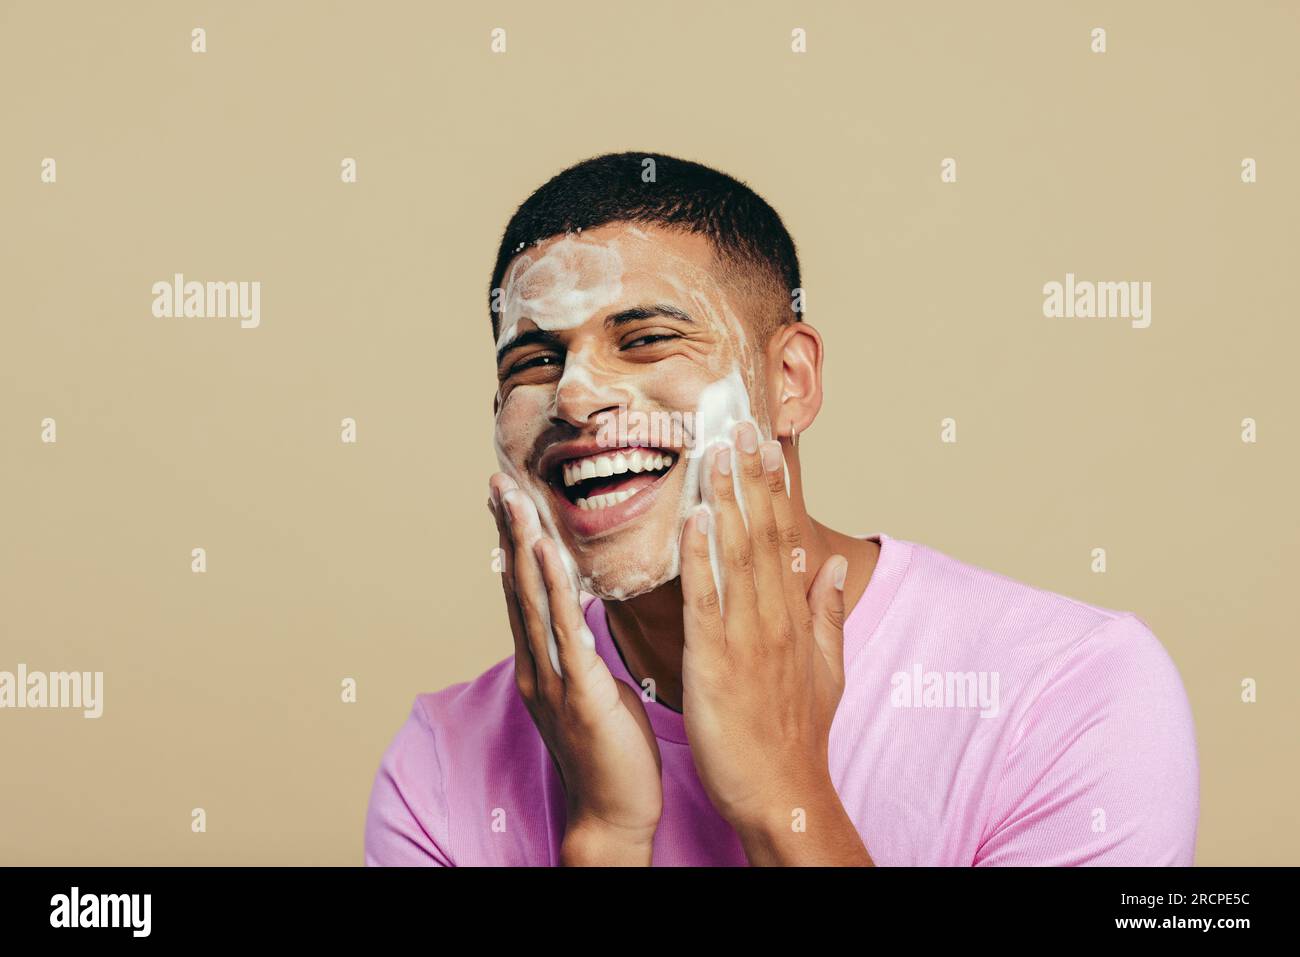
974;614;1200;866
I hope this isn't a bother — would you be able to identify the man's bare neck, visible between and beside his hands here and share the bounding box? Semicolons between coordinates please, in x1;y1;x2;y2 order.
605;510;880;711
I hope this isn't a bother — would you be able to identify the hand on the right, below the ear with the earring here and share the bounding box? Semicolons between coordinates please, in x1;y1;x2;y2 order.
681;424;871;865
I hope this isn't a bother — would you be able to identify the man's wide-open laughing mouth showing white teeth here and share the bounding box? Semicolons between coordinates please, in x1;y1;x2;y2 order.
546;446;680;538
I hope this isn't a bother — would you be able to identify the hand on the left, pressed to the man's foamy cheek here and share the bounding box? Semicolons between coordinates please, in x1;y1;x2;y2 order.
488;472;663;866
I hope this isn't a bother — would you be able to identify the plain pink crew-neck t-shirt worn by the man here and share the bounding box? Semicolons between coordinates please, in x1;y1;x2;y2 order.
365;534;1199;866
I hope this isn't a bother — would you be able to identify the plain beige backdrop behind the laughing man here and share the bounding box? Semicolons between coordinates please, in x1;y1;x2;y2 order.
0;0;1300;865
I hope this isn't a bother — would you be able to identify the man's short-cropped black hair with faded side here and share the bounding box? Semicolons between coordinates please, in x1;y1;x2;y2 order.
488;152;802;341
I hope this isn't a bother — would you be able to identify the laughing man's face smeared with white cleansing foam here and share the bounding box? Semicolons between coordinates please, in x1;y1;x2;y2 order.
495;224;770;601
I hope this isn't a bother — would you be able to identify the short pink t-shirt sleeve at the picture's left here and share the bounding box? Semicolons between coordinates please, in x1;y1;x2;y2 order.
365;698;454;867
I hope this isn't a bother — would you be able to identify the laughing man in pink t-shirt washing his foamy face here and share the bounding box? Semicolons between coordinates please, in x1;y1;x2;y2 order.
365;153;1199;866
